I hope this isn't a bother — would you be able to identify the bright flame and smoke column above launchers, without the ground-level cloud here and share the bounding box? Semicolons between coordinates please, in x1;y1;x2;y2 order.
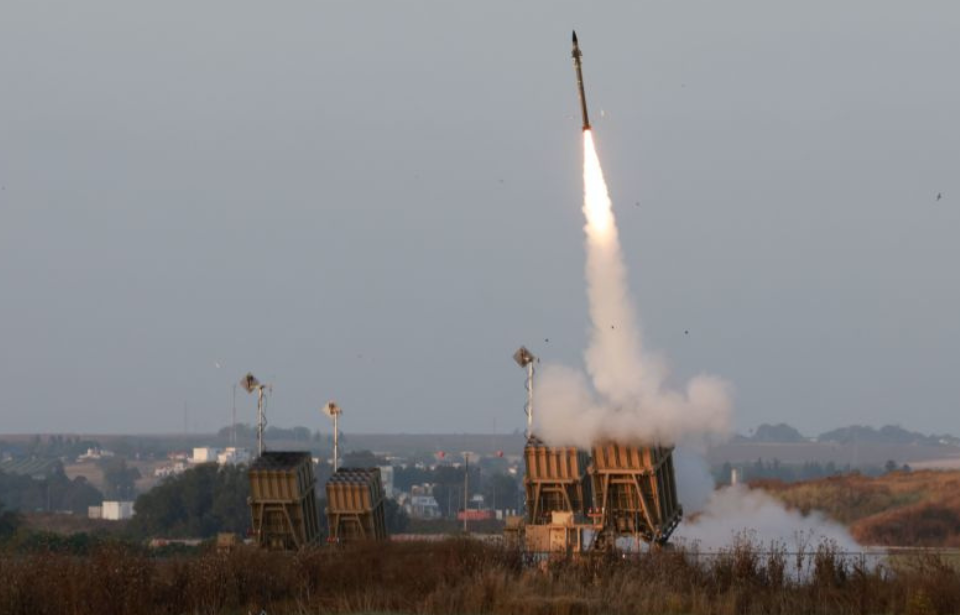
536;130;730;447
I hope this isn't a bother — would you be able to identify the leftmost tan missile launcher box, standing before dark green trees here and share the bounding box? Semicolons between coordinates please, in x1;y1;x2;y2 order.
248;451;320;549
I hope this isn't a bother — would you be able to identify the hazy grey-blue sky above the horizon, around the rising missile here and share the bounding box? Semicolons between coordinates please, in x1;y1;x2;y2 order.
0;0;960;434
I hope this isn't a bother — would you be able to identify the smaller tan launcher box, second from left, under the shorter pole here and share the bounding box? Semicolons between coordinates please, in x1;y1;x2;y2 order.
327;468;387;542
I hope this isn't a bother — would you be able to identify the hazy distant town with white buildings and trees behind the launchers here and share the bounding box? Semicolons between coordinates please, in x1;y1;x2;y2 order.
0;424;960;542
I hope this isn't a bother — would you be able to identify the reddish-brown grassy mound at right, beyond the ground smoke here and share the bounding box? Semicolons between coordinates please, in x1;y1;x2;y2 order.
752;470;960;547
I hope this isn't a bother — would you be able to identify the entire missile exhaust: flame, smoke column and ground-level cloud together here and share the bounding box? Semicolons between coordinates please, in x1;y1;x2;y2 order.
535;131;856;550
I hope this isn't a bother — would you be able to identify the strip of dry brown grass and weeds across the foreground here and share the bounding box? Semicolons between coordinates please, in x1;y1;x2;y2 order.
0;540;960;615
